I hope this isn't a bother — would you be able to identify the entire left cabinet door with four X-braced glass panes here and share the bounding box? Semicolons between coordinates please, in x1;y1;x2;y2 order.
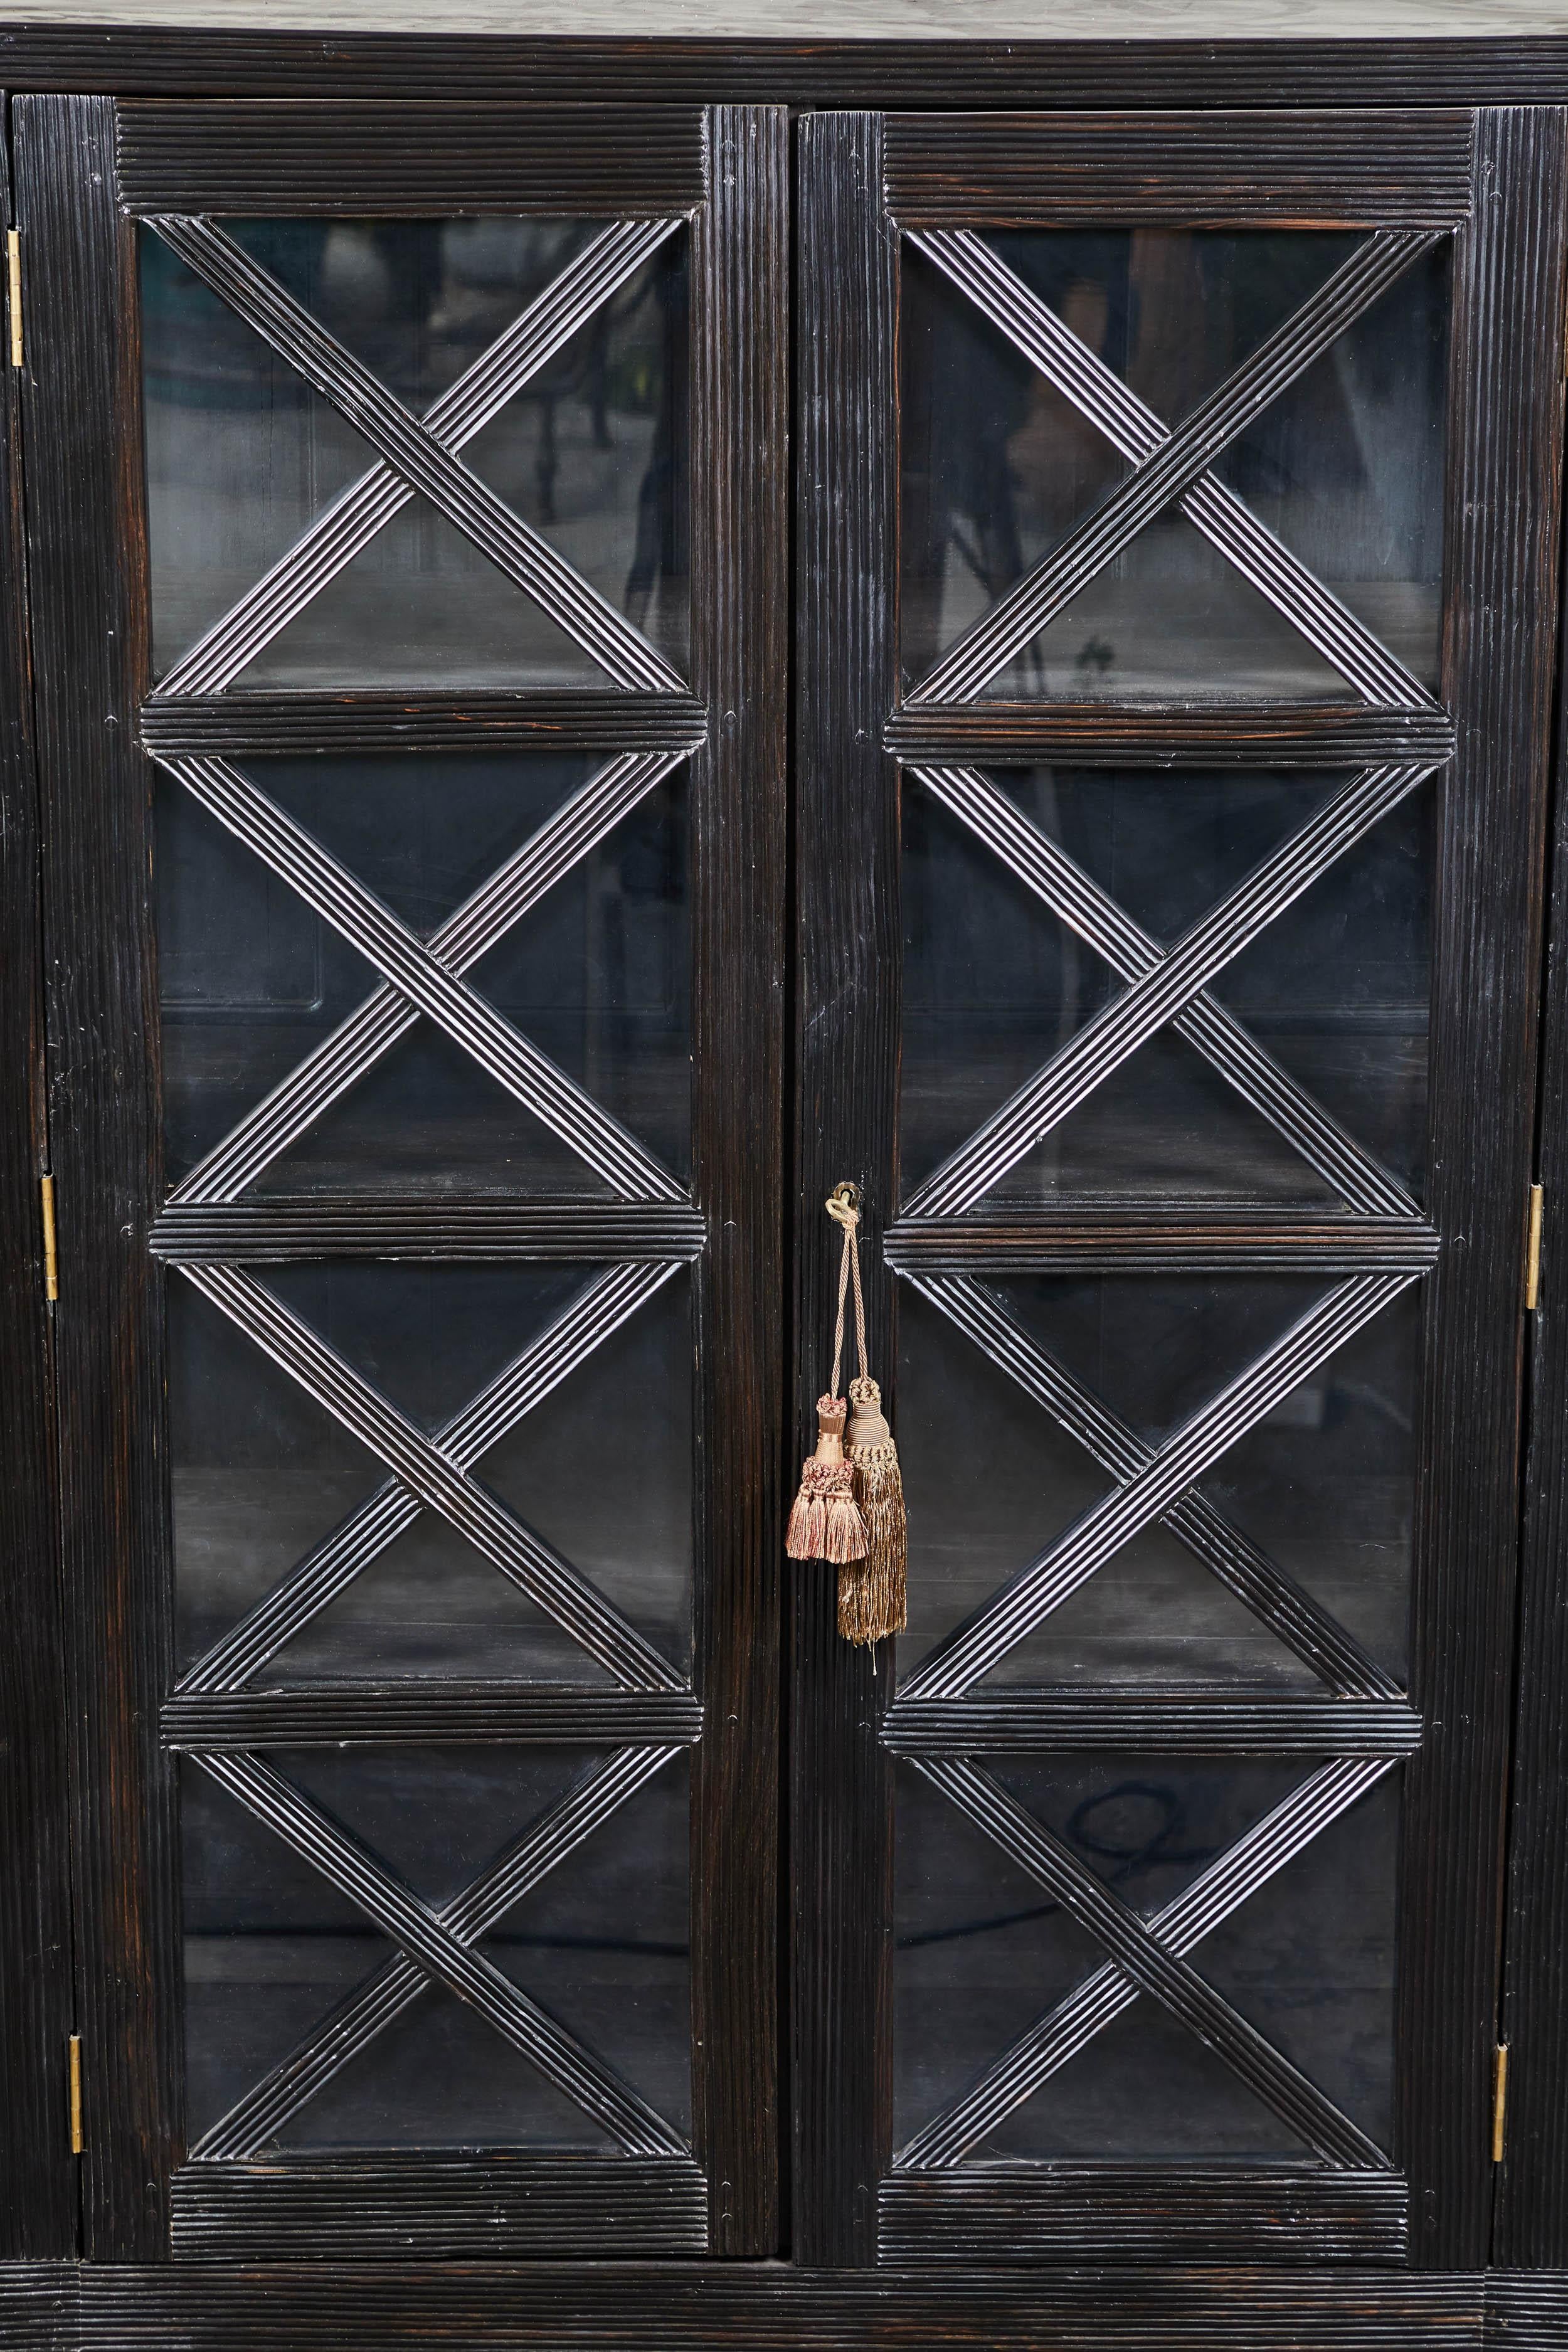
19;99;785;2260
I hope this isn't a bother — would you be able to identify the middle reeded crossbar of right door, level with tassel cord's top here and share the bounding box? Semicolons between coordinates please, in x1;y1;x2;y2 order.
884;1202;1439;1275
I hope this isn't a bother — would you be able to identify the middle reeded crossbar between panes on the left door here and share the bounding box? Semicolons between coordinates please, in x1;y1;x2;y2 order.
151;1192;705;1266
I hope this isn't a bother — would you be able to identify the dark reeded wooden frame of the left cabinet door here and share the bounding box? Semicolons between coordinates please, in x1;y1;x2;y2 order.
19;97;788;2260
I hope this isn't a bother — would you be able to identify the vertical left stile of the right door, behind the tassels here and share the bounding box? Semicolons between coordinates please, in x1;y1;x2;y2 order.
790;115;901;2265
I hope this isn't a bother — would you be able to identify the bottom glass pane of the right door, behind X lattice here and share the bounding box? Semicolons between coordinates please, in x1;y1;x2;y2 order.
893;1755;1399;2164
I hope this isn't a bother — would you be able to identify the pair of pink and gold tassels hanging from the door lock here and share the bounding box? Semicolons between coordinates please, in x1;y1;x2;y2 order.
785;1185;908;1644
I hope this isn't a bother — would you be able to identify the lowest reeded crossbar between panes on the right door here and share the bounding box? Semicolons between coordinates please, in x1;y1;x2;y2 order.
882;1687;1422;1757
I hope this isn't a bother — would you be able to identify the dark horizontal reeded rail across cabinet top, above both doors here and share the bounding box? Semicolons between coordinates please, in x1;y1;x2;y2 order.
0;32;1568;110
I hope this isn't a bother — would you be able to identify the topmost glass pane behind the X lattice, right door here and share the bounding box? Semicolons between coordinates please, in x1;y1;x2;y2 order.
901;228;1448;701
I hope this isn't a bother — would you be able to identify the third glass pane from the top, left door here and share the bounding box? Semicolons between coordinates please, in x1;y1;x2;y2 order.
169;1263;694;1687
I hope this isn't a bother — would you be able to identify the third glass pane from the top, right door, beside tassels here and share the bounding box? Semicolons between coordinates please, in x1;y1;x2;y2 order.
898;1275;1420;1691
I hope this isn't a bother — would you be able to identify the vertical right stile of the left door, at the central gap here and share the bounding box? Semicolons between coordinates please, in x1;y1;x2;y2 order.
691;109;790;2260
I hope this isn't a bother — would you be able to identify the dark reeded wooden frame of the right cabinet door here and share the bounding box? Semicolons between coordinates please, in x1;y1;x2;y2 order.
792;109;1564;2267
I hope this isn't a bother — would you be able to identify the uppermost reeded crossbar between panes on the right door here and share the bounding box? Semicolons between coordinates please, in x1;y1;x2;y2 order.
882;699;1453;767
